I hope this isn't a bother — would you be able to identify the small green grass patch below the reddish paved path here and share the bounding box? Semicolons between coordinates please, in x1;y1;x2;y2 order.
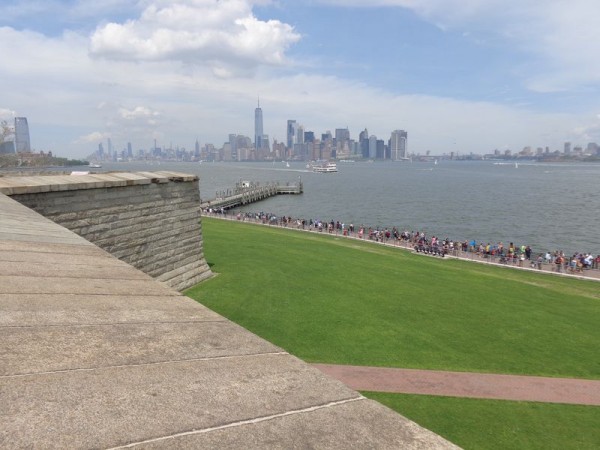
363;392;600;450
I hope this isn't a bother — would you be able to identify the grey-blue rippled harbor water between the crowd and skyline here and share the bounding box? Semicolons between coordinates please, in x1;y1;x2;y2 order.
103;161;600;254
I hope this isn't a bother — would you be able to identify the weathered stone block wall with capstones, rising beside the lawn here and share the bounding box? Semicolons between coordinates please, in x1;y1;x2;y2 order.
7;173;212;291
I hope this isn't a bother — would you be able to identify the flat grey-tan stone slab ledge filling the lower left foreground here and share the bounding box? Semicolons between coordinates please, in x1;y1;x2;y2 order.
0;194;456;449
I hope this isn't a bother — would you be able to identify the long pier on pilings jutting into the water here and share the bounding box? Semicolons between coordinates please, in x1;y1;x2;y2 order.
200;180;304;210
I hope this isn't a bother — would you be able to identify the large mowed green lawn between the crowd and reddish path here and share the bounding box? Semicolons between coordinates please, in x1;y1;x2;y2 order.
186;218;600;379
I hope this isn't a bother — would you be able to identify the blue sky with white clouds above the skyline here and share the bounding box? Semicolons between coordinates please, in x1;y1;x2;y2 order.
0;0;600;157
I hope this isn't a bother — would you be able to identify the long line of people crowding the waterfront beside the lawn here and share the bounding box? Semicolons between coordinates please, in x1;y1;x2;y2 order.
205;208;600;273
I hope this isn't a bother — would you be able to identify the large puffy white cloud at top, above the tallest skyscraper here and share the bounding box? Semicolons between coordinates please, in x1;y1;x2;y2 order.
90;0;300;75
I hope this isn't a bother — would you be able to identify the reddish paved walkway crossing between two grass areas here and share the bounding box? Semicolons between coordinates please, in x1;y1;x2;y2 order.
313;364;600;406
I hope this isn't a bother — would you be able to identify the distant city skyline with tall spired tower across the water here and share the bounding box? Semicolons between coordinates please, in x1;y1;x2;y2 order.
86;101;600;161
